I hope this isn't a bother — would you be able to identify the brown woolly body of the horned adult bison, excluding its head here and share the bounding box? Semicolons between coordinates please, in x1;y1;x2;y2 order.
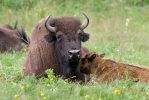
23;19;58;77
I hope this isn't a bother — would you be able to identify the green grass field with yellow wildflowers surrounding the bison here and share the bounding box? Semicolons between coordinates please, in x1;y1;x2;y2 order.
0;0;149;100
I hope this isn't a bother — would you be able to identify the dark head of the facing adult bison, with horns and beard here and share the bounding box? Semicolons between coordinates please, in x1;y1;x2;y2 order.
45;12;89;78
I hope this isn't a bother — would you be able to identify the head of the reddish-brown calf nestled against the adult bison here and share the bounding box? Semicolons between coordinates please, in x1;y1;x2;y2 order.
80;52;105;74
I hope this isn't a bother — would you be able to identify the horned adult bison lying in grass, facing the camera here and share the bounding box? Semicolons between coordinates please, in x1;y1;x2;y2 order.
23;12;89;82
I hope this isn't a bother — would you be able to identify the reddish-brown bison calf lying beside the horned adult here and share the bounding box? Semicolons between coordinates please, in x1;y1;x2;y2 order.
80;52;149;83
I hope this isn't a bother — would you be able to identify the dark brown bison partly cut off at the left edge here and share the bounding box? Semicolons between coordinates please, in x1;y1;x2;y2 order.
0;22;29;53
